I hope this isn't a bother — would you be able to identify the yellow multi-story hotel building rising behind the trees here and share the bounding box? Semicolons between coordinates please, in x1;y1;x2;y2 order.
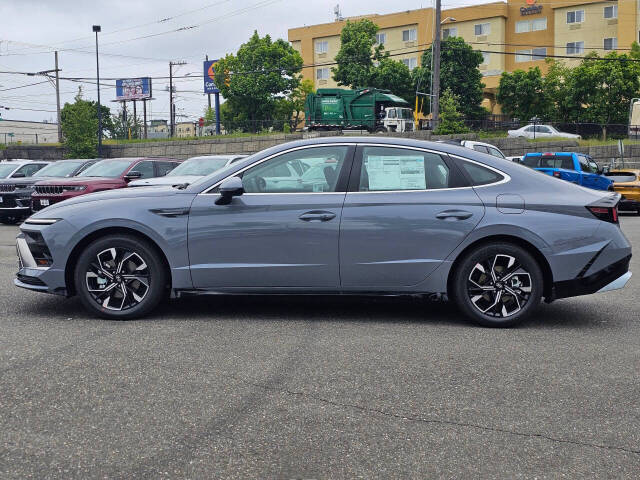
289;0;640;113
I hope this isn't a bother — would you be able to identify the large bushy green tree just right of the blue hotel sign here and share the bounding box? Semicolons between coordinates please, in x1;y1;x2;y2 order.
216;31;302;131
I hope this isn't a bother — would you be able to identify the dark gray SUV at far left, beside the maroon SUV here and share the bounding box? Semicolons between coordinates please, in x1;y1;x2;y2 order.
0;160;97;224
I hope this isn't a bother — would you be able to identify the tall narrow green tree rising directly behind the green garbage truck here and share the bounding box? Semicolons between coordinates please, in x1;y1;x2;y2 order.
331;18;384;88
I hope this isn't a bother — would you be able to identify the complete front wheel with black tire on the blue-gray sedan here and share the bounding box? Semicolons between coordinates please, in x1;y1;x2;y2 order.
74;235;168;320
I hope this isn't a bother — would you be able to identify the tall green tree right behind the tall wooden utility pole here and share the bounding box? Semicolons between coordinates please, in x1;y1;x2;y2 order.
412;37;487;119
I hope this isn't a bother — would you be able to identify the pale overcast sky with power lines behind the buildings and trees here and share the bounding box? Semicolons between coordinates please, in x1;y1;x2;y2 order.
0;0;484;122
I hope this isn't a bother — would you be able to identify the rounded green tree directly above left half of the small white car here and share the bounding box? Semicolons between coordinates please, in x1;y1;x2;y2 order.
496;67;551;122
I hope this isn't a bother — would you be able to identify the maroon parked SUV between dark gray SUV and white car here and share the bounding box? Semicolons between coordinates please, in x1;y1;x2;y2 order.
31;158;180;211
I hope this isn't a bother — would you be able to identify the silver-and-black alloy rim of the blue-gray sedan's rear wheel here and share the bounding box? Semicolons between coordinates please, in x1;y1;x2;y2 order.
467;254;532;318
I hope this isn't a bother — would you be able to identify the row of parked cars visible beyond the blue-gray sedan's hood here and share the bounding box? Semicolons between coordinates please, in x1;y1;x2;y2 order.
0;155;244;224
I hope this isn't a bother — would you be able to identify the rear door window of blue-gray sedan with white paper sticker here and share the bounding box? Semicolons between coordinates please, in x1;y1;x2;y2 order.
358;147;451;192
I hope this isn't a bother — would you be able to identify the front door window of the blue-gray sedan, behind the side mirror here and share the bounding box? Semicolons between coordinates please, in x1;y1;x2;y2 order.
242;146;349;193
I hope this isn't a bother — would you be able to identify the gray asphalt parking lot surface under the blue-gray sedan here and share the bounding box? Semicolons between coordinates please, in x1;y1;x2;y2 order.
0;216;640;478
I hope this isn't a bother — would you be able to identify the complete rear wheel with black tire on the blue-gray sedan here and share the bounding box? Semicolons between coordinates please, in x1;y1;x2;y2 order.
449;243;544;327
